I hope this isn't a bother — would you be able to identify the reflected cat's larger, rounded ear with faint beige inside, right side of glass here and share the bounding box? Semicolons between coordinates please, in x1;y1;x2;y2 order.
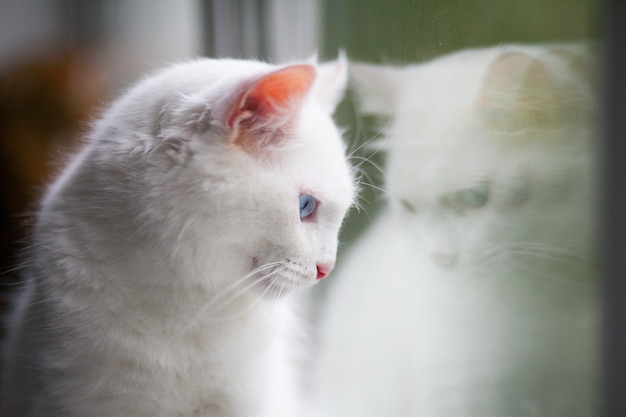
478;52;558;132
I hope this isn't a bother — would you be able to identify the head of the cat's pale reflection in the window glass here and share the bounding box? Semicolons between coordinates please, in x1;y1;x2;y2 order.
354;45;595;278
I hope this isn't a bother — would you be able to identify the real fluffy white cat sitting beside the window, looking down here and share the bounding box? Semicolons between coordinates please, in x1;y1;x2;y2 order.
4;58;355;417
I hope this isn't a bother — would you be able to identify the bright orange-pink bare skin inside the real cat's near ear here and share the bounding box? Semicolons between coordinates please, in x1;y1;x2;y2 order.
228;65;315;128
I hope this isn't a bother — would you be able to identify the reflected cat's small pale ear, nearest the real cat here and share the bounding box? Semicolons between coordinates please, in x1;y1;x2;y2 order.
350;63;404;116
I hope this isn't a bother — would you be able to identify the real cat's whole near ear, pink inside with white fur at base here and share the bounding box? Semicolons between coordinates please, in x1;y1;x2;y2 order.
226;65;315;150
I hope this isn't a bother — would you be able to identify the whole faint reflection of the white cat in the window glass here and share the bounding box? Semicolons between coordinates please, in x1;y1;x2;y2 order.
312;45;598;417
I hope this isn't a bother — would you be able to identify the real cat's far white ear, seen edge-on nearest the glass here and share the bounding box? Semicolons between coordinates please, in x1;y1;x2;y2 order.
311;50;348;114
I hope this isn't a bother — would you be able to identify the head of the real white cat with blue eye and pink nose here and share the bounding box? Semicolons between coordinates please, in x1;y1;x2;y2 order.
88;57;355;295
